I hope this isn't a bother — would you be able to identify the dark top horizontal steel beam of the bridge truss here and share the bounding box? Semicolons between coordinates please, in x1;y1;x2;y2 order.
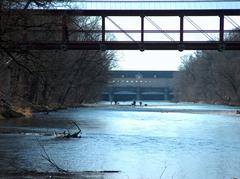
0;9;240;16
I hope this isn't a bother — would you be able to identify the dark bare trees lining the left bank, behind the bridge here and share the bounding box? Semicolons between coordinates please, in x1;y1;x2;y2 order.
0;0;115;110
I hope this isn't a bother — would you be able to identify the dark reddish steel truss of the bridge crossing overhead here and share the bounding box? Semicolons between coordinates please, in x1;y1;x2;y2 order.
0;9;240;51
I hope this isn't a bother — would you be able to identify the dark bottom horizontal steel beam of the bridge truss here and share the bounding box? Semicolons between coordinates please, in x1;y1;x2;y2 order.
7;41;240;50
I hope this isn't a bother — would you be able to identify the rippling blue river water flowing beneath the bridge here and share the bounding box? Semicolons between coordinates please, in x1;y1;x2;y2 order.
0;102;240;179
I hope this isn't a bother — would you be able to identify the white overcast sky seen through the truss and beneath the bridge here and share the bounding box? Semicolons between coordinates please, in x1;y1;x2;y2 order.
106;16;240;71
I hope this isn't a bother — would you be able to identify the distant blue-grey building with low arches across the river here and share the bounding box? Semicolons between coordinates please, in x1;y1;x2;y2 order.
102;71;178;101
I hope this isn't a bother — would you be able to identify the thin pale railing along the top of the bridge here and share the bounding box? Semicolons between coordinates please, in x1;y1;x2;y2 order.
63;0;240;10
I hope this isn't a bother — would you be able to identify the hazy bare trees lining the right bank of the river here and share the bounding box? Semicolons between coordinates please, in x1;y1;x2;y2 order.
174;32;240;105
